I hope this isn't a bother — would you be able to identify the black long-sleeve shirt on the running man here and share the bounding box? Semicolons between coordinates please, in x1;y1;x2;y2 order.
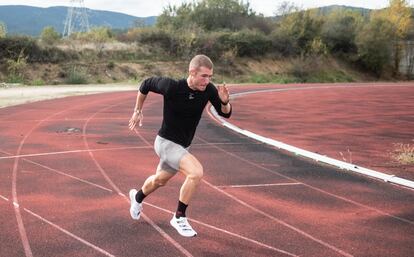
139;77;231;147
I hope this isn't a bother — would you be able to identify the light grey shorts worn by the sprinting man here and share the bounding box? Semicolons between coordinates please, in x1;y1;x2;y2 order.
154;136;188;174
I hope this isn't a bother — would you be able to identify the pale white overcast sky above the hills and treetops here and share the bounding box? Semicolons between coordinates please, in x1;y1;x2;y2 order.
0;0;406;17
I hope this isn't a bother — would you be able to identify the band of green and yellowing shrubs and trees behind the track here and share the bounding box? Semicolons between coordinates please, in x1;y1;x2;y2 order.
0;0;414;85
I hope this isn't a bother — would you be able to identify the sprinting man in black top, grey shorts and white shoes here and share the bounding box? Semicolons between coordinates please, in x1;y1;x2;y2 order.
129;55;232;237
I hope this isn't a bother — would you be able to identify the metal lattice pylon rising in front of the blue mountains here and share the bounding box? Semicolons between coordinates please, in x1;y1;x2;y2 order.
63;0;90;37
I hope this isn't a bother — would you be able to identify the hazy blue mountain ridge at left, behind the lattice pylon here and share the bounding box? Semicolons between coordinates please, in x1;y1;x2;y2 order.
0;5;156;36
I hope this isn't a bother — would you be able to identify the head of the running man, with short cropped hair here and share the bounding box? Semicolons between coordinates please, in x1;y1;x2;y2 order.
187;54;213;91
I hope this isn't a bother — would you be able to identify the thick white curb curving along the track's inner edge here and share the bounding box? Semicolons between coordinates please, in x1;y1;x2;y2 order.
210;85;414;189
